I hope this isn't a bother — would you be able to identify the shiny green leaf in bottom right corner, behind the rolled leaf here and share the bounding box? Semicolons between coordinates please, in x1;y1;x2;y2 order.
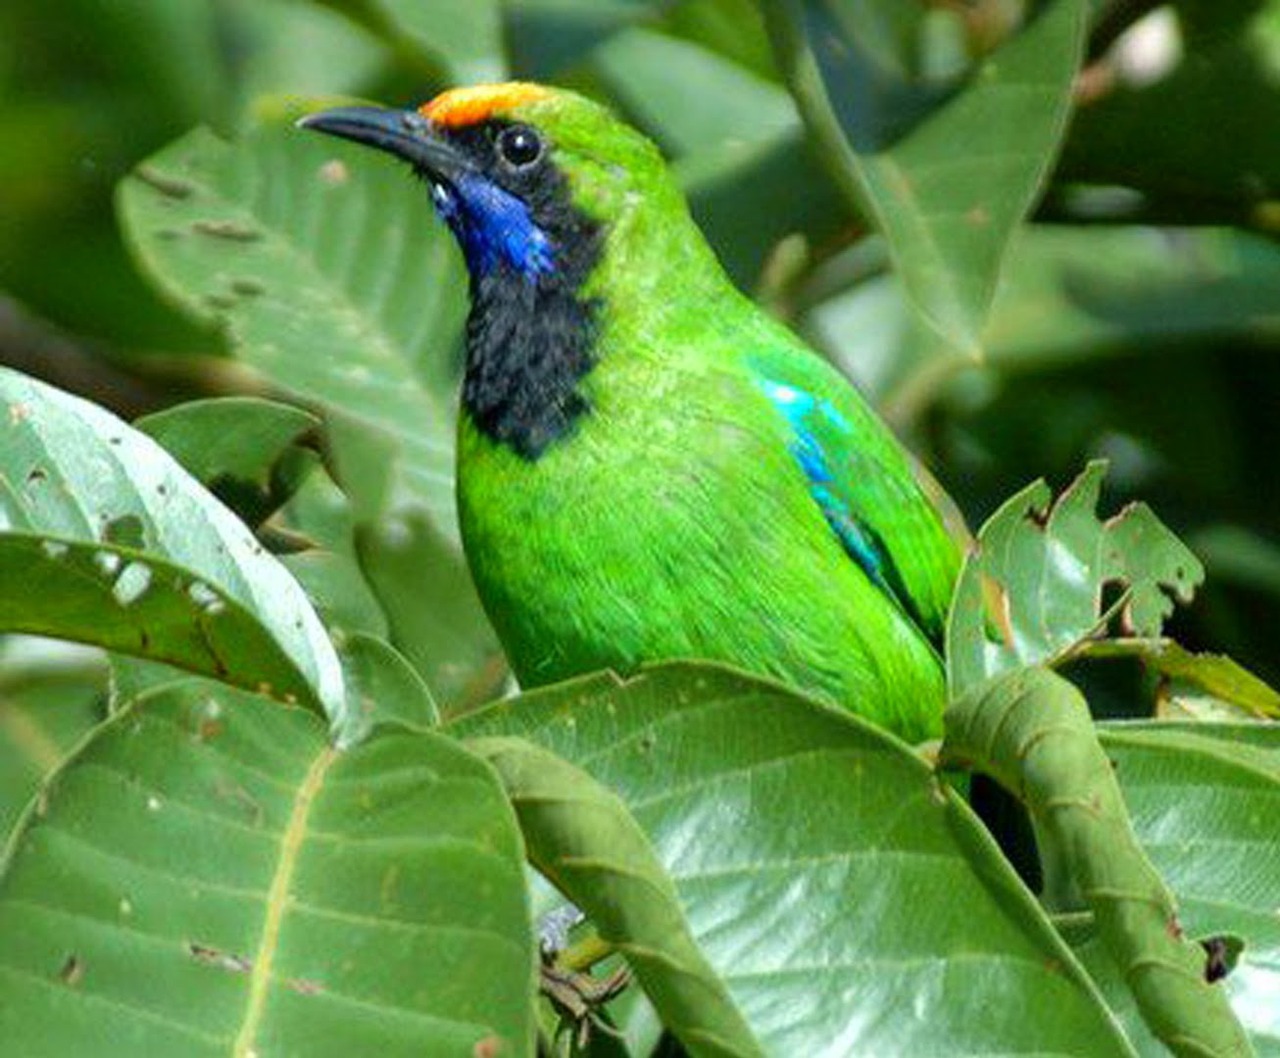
1082;723;1280;1058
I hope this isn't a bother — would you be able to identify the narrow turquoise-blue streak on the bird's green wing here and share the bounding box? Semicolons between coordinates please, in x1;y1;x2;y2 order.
759;379;919;623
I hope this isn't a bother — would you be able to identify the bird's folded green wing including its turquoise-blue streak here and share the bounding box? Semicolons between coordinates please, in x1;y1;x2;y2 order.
748;351;960;646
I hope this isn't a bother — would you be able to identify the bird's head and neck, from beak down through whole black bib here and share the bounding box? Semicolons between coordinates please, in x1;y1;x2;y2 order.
301;82;718;459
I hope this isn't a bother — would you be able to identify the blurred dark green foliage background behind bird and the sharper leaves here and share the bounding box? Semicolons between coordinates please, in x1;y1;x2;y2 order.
0;0;1280;686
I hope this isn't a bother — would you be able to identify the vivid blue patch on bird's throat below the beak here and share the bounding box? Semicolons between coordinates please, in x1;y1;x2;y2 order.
431;174;554;279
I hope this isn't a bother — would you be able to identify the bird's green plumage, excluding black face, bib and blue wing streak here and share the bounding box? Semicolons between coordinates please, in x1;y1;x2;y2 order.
458;93;959;739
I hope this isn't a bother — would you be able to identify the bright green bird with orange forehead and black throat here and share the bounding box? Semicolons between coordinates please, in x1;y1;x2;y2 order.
302;83;960;739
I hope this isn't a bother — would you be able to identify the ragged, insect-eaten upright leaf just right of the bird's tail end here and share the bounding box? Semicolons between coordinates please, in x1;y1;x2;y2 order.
947;461;1204;695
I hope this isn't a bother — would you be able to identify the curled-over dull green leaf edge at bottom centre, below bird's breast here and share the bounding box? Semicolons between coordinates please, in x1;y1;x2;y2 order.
467;738;763;1058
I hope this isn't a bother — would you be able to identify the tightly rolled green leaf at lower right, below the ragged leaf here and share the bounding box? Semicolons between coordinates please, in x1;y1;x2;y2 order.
940;667;1253;1058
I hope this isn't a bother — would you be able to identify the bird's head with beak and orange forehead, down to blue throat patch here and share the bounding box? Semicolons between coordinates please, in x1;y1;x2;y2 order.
301;82;675;283
